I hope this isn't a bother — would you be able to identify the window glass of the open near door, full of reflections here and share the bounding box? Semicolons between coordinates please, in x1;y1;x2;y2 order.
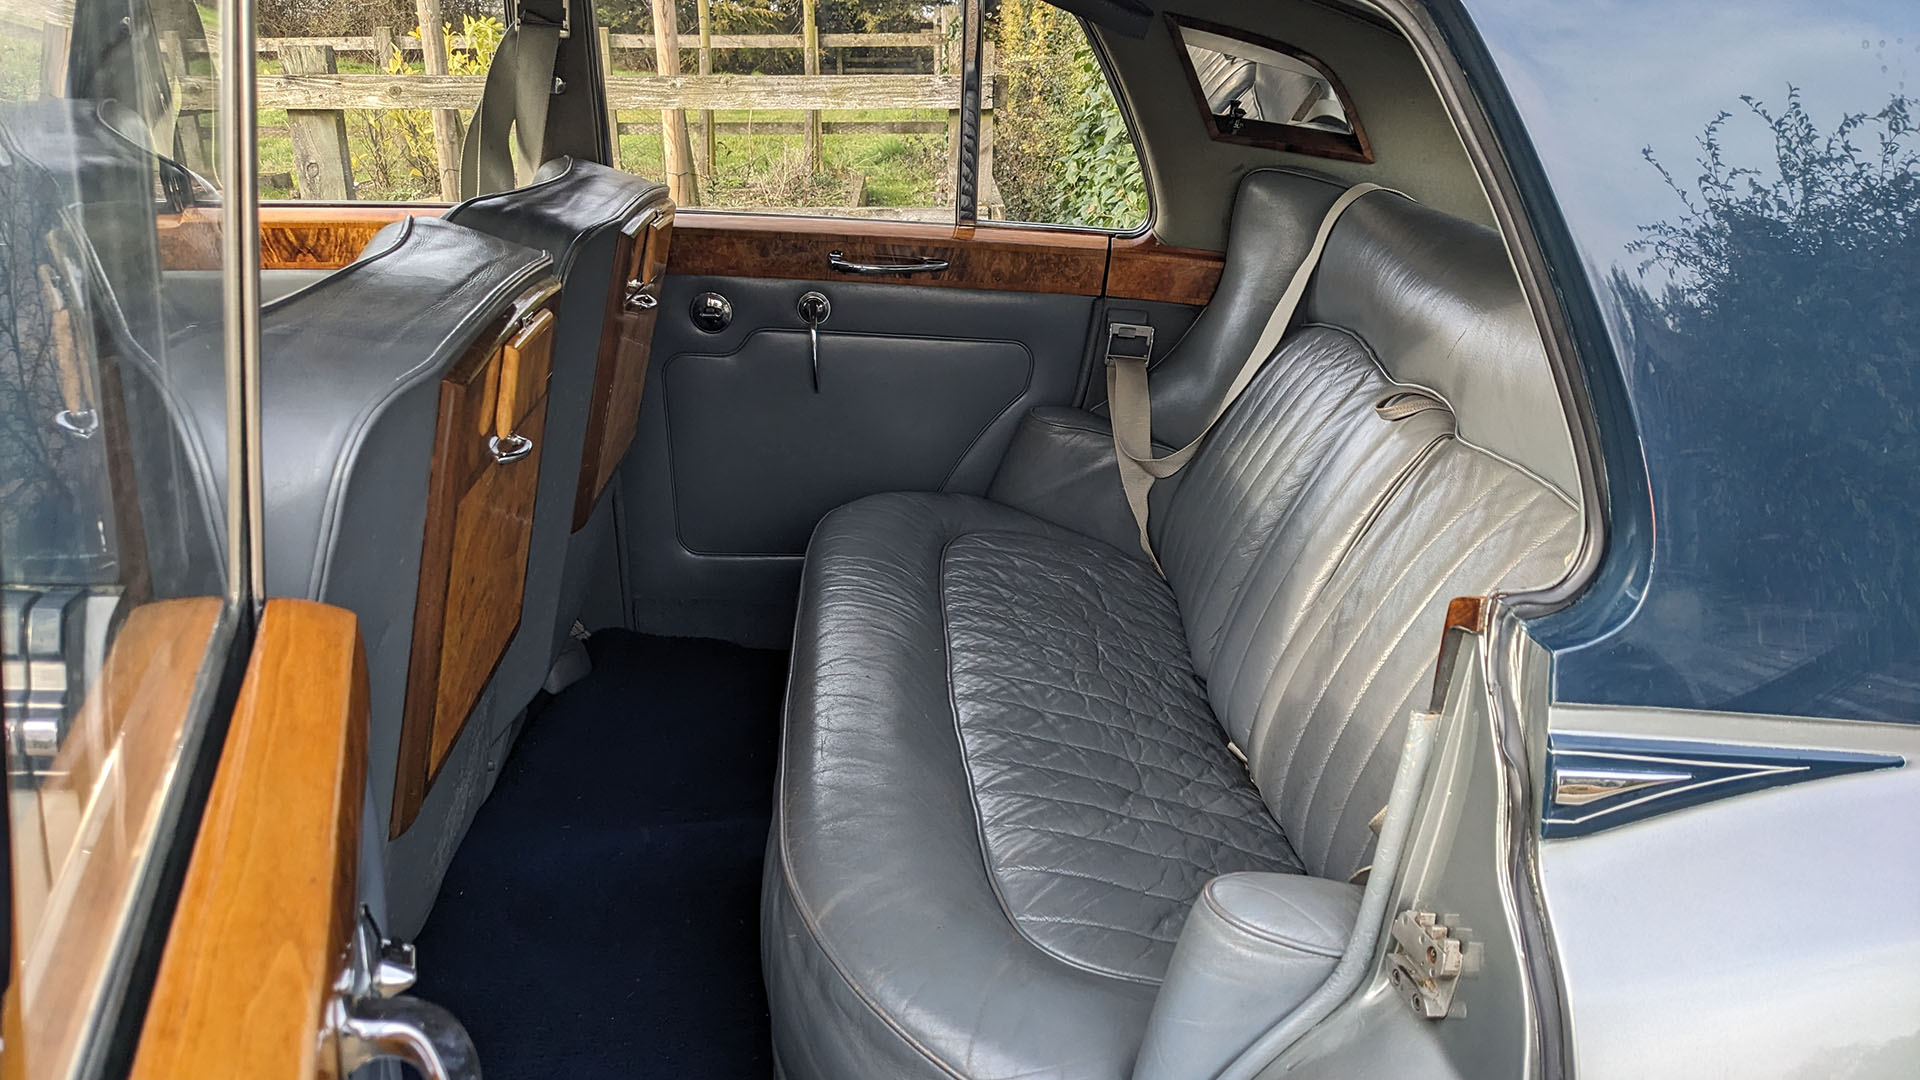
0;0;248;1076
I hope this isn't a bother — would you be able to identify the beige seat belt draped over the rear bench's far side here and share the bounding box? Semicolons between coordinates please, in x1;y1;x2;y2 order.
1106;184;1390;569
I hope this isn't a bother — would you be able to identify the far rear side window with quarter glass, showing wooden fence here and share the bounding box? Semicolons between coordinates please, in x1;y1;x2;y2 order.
601;0;1146;229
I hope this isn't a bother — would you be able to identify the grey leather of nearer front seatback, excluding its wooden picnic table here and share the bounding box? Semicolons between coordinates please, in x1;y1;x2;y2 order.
169;217;553;936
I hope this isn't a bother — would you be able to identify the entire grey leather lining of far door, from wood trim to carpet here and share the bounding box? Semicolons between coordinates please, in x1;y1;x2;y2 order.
618;272;1094;648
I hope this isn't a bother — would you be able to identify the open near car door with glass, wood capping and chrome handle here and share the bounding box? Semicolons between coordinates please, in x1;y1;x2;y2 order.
0;0;476;1080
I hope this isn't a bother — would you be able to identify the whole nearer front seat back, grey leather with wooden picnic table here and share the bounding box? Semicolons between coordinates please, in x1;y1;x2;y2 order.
169;219;559;934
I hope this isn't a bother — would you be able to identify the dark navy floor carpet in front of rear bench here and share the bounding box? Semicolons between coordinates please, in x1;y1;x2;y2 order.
417;630;785;1080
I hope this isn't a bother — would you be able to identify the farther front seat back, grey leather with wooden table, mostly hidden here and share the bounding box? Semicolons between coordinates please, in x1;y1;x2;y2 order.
445;158;674;687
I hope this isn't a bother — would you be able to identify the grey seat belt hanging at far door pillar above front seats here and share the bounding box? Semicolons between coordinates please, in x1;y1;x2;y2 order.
461;0;568;198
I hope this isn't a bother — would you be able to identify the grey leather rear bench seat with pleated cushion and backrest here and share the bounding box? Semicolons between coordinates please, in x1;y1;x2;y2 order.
762;173;1578;1080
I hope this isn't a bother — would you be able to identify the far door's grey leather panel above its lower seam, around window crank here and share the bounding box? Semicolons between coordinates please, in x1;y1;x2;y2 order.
649;279;1092;555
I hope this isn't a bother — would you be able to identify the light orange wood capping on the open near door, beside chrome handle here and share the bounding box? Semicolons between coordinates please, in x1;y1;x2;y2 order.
132;600;367;1080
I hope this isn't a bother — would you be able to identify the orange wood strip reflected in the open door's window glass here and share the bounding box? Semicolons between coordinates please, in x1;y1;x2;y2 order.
4;596;221;1076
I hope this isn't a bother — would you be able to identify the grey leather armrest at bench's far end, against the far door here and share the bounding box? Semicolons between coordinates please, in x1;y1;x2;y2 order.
987;405;1177;557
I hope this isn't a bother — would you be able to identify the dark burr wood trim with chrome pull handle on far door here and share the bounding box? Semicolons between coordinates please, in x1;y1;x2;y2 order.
666;211;1108;296
